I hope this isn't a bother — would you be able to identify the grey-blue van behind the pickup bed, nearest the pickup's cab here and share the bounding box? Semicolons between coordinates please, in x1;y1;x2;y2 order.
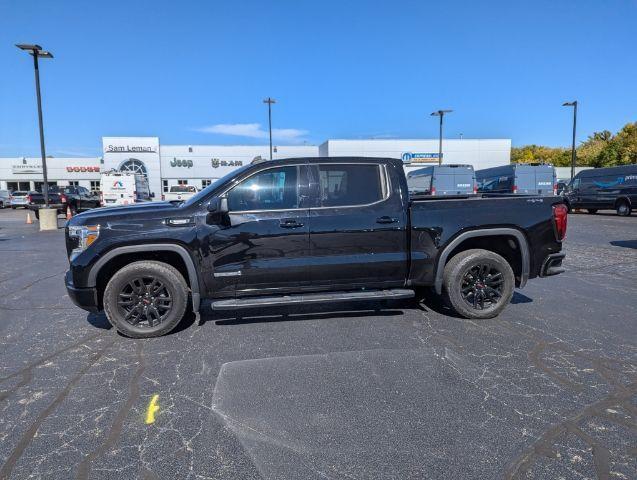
407;165;478;195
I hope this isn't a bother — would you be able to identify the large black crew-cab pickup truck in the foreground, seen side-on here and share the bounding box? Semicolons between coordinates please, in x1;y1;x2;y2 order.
66;157;567;337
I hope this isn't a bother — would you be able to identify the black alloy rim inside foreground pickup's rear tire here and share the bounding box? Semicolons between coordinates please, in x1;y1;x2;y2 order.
461;263;504;310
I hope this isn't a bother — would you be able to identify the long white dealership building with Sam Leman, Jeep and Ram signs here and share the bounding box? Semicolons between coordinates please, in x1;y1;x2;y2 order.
0;137;511;198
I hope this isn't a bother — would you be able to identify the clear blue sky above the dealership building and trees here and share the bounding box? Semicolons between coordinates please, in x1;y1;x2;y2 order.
0;0;637;156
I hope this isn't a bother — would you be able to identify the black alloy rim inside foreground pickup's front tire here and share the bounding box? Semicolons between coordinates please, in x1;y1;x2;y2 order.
117;276;173;328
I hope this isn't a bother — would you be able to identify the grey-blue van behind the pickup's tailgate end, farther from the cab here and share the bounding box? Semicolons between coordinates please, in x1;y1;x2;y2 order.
476;163;557;195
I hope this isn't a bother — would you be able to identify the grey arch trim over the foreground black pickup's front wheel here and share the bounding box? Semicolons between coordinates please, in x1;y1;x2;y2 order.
88;243;201;312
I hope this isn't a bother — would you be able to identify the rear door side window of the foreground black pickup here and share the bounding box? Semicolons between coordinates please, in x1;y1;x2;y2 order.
319;163;388;207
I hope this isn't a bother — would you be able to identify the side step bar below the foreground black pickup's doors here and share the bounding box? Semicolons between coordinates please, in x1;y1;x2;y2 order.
210;289;415;310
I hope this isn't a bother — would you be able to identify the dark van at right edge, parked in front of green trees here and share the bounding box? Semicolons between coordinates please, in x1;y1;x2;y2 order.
564;165;637;216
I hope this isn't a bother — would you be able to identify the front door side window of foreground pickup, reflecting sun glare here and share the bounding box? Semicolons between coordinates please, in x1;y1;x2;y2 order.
228;166;299;212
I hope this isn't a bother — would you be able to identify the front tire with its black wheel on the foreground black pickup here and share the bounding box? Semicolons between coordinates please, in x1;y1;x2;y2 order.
103;260;188;338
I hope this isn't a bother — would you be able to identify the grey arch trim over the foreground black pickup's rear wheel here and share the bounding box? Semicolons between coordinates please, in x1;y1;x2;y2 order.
434;227;531;294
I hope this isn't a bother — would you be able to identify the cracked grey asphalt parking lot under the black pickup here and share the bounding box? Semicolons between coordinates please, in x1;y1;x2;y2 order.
0;210;637;479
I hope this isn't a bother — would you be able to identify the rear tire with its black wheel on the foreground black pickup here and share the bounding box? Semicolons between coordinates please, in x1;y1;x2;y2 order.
443;249;515;319
